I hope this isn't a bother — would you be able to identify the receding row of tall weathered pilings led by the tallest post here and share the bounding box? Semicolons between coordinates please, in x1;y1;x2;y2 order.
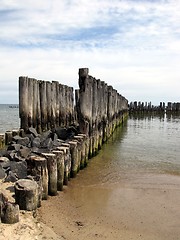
76;68;128;157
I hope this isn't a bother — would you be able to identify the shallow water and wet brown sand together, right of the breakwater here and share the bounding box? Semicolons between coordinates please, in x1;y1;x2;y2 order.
41;115;180;240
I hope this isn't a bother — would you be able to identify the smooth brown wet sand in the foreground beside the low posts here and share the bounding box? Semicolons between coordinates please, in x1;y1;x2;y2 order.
38;170;180;240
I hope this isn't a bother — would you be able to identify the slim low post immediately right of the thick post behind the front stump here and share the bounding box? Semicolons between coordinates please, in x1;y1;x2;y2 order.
42;153;57;196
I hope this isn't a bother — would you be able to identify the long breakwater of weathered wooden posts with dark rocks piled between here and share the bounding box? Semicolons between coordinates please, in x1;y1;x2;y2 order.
0;68;128;223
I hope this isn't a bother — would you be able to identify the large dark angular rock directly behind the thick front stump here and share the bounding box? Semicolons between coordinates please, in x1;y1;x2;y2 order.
10;161;27;179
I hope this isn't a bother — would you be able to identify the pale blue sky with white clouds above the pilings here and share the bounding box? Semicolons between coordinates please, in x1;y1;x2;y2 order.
0;0;180;105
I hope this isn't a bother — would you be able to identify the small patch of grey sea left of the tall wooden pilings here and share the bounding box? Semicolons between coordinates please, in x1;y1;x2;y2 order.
0;104;20;133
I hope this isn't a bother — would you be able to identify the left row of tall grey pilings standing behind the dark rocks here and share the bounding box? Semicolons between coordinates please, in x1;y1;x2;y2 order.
19;77;75;133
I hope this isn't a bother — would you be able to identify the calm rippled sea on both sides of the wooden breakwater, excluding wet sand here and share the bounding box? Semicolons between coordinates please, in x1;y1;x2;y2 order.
0;104;180;175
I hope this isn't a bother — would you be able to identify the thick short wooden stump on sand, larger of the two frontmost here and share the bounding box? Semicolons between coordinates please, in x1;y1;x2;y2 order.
14;179;38;211
